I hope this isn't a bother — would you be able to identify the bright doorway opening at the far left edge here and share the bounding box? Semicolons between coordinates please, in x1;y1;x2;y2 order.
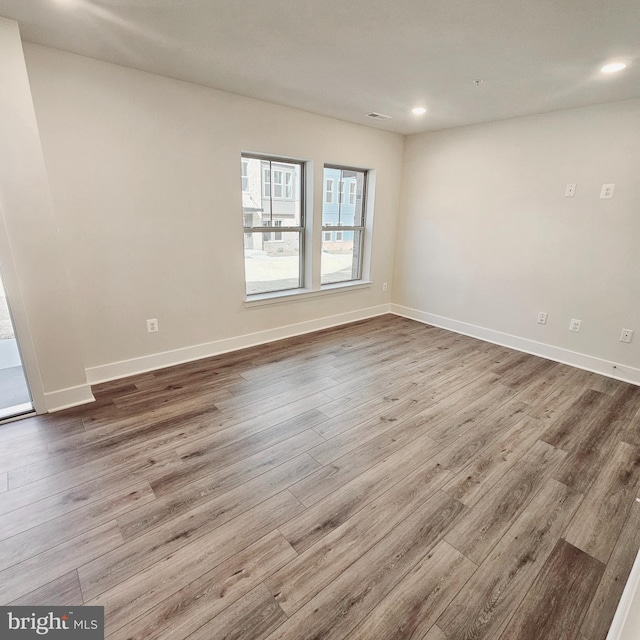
0;273;33;420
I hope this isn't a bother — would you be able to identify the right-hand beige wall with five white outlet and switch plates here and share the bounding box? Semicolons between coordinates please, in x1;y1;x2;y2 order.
393;101;640;383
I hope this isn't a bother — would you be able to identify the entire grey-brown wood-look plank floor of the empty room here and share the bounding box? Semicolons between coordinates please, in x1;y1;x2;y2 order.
0;315;640;640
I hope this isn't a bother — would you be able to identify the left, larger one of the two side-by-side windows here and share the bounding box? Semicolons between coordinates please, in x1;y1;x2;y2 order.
242;154;305;296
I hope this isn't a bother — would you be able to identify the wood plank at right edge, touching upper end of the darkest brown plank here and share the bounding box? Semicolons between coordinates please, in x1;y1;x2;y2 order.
565;442;640;564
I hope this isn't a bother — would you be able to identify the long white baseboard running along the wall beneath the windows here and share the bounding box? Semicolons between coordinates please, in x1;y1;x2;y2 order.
86;304;389;384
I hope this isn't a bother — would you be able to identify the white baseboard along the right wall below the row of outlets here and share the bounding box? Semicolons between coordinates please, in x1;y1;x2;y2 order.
391;304;640;385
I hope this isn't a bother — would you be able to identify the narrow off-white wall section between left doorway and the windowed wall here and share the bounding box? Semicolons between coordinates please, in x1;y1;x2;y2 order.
0;18;92;411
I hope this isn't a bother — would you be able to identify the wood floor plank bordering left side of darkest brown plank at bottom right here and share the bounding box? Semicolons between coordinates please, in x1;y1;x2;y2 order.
436;479;582;640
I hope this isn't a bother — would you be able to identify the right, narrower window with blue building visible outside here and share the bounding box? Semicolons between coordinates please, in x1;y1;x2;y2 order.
320;165;367;284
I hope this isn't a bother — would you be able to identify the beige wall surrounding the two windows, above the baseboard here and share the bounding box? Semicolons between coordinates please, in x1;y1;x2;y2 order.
24;43;404;379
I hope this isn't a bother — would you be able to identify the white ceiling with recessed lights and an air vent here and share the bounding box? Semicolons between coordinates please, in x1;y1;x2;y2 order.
0;0;640;134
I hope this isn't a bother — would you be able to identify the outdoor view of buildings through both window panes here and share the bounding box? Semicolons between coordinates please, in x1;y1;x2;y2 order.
241;155;366;295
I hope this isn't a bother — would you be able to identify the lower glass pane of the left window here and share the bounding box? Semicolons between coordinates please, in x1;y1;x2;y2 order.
244;231;300;295
